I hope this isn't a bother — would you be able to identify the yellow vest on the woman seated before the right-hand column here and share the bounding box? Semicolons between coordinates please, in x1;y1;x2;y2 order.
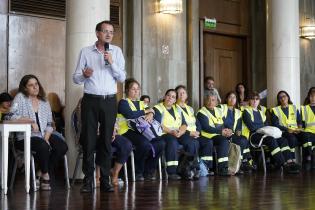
272;104;298;129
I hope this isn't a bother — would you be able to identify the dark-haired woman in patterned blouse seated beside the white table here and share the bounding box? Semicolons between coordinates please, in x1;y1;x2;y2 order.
11;74;68;190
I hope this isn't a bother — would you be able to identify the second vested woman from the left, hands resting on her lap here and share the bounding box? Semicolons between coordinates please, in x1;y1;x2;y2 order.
154;89;199;180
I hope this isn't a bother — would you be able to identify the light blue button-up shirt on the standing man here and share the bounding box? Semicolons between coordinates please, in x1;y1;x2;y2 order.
73;44;126;95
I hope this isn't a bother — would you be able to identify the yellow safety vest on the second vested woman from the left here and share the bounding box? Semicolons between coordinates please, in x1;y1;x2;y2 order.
154;103;182;130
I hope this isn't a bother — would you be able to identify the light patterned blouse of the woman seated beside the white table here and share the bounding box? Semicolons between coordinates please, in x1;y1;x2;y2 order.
10;93;53;139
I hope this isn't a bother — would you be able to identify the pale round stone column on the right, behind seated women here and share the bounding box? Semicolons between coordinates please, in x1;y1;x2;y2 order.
266;0;300;107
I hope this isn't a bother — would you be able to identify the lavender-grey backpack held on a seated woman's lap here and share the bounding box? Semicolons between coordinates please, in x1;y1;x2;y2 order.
128;116;163;141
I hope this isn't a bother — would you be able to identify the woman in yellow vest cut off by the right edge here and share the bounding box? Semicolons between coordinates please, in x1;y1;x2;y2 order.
301;87;315;170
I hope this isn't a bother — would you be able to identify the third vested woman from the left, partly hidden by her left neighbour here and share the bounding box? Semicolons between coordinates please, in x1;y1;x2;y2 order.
175;85;207;176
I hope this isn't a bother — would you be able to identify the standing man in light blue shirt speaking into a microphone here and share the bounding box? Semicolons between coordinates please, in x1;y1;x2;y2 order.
73;21;126;193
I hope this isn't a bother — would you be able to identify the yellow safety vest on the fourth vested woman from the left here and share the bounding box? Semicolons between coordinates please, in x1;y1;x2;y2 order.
198;107;223;138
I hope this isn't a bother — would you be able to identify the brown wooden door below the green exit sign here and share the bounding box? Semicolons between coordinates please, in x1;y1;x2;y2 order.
201;32;246;102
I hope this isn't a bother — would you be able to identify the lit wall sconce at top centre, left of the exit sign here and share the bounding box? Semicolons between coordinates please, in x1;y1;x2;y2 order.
158;0;183;14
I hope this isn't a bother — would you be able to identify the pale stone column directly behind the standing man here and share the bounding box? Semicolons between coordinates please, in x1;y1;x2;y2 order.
65;0;110;176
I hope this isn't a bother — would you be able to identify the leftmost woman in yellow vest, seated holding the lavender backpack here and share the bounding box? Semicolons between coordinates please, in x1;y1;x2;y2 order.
117;78;165;181
